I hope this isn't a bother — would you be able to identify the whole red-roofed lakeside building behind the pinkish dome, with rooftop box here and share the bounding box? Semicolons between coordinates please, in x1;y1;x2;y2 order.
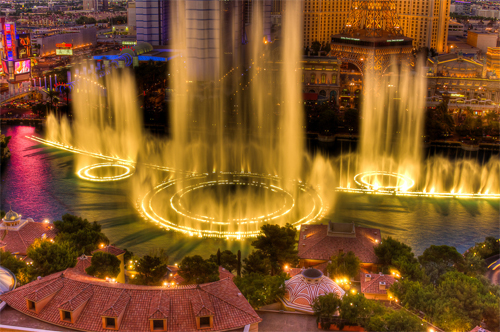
298;221;382;270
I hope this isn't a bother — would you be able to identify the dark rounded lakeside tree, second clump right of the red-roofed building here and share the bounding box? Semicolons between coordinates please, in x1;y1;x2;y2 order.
418;245;463;284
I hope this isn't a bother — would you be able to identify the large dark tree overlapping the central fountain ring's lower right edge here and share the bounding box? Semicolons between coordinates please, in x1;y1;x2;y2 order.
252;224;299;275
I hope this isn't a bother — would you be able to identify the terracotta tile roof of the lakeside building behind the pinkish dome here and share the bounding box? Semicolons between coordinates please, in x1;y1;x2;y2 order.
298;225;382;263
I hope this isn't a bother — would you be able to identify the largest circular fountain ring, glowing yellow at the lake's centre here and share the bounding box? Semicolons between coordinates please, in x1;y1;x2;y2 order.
137;173;325;239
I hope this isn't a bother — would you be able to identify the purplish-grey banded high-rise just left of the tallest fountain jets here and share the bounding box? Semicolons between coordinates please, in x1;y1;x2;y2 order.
135;0;170;45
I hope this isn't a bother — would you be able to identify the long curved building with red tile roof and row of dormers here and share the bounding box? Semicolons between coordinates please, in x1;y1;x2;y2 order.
0;268;262;332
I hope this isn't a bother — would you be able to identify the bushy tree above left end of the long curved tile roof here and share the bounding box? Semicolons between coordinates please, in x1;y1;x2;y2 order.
28;239;77;277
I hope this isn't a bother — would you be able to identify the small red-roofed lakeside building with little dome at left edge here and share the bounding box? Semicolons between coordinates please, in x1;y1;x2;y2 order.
0;209;56;260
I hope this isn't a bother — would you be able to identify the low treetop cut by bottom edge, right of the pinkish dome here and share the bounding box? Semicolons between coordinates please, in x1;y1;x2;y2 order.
366;310;427;332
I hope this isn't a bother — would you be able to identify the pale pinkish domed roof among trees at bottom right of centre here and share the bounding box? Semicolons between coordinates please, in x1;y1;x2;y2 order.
282;269;345;313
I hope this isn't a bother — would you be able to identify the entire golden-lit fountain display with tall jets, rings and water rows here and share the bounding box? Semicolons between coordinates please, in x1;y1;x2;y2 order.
36;0;500;239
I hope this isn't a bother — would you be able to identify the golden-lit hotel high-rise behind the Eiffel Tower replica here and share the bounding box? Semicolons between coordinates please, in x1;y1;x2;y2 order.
303;0;451;52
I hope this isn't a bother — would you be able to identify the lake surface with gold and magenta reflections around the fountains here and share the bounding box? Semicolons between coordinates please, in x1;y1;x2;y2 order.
1;127;500;255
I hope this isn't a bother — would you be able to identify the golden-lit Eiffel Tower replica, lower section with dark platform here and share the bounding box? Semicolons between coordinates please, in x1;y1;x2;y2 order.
330;0;413;75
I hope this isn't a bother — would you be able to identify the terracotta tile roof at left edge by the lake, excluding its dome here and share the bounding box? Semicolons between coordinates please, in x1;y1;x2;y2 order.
0;221;56;256
